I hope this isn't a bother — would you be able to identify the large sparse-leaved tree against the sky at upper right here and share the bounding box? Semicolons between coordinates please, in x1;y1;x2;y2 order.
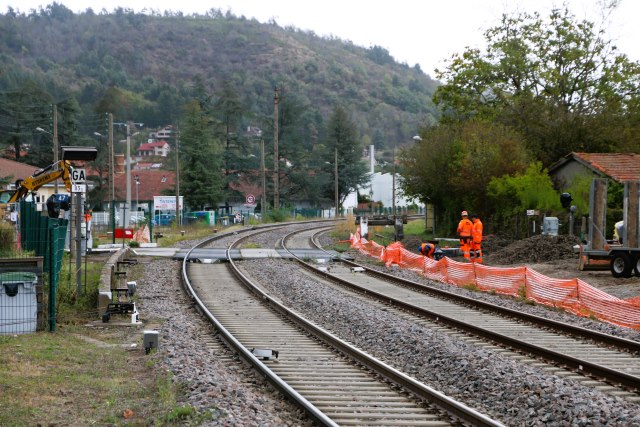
434;9;640;166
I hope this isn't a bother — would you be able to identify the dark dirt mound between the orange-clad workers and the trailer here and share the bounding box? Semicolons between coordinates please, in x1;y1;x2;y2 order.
482;235;580;265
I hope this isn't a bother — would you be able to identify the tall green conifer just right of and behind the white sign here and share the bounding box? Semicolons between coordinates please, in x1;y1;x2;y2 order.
180;101;224;209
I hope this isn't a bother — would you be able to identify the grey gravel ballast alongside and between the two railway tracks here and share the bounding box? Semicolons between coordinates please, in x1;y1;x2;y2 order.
134;226;640;426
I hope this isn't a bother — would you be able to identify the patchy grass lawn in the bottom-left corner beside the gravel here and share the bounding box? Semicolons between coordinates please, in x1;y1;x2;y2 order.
0;331;182;426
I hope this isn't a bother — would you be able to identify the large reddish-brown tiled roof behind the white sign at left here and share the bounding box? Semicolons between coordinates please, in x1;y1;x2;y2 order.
114;170;176;202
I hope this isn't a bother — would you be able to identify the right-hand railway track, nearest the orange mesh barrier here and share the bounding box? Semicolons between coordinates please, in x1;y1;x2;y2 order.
282;230;640;402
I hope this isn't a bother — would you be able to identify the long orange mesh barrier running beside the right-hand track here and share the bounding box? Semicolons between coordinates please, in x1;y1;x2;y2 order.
350;233;640;329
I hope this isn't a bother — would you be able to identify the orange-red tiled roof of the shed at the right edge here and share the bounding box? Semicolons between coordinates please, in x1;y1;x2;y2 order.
571;153;640;182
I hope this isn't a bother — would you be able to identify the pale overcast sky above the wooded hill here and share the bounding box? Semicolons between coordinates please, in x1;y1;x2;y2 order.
0;0;640;77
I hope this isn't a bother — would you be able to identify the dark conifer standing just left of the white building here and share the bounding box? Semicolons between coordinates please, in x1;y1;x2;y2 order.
324;106;369;206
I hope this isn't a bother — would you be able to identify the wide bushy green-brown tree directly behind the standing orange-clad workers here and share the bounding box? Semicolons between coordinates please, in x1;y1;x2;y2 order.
399;119;529;222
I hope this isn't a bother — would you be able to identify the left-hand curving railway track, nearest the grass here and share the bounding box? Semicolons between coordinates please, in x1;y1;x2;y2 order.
182;222;501;426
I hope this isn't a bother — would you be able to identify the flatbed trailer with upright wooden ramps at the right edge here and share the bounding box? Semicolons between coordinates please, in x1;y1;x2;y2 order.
578;178;640;277
